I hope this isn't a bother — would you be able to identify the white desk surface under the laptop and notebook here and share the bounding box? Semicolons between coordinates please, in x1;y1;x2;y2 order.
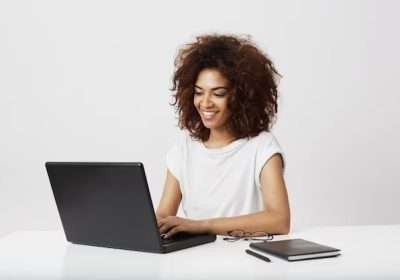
0;225;400;280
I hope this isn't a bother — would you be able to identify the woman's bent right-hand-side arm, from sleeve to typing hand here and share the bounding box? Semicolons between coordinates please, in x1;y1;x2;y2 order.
159;154;290;236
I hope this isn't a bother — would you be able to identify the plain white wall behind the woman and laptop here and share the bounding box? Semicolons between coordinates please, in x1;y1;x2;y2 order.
0;0;400;234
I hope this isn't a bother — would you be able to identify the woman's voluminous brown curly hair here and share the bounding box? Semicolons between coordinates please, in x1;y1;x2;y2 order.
171;34;281;141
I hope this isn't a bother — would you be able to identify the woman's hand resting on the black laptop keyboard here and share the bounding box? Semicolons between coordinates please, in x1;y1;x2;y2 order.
157;216;208;238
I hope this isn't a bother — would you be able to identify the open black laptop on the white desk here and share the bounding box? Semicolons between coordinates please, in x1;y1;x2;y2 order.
46;162;216;253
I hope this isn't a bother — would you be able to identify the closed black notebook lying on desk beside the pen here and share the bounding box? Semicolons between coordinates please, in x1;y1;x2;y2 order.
250;239;340;261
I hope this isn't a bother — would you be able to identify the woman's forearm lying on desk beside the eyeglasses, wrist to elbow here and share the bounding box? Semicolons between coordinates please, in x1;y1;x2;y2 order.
204;211;290;235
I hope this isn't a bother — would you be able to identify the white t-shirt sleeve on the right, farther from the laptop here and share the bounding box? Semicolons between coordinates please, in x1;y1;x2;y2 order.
255;133;286;187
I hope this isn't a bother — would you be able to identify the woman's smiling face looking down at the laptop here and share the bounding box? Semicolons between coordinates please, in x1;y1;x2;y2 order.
194;69;231;132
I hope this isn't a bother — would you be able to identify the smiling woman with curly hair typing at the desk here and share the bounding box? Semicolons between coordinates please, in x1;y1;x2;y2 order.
156;35;290;238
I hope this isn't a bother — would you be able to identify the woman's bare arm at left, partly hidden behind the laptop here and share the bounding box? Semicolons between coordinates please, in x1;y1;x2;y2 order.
156;169;182;220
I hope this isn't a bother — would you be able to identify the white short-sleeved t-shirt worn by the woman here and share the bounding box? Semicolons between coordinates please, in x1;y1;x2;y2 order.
166;131;285;219
